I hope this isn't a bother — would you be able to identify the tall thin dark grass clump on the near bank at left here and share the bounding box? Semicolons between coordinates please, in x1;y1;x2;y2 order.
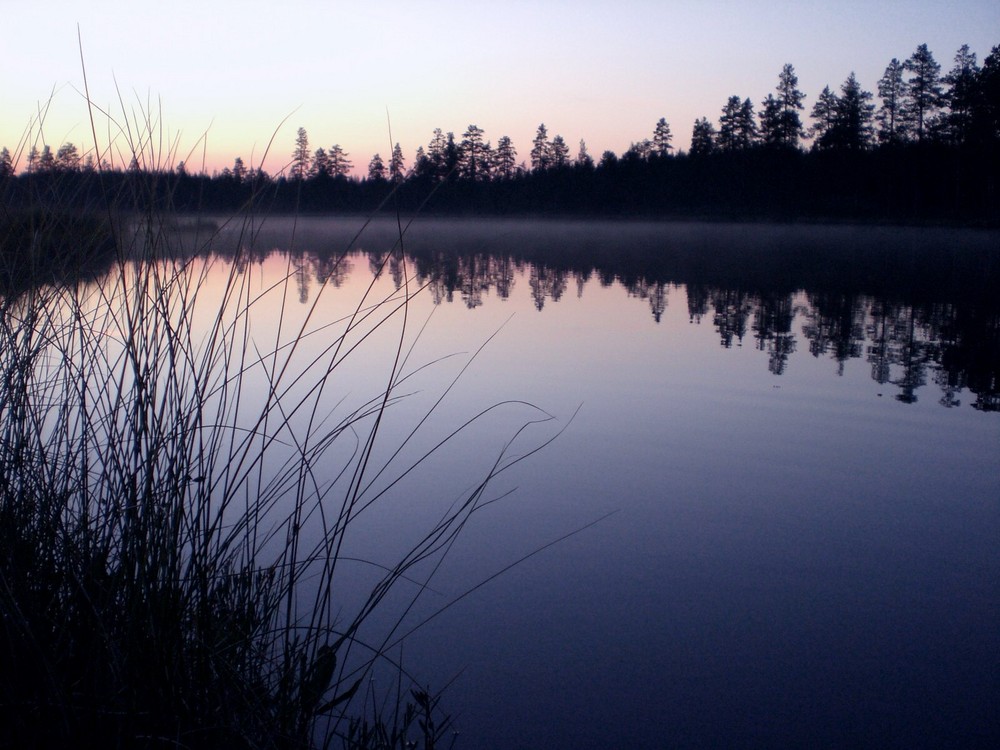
0;97;556;748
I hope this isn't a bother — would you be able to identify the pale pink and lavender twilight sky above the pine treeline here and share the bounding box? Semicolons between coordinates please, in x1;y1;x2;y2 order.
0;0;1000;174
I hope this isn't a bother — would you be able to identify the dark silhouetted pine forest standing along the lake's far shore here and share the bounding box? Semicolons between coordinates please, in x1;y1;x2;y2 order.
0;45;1000;226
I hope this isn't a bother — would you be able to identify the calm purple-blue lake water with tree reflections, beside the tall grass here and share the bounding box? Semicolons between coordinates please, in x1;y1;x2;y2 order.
48;218;1000;750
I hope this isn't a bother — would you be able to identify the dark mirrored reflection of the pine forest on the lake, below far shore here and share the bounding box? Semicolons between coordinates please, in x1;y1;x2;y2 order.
7;219;1000;411
